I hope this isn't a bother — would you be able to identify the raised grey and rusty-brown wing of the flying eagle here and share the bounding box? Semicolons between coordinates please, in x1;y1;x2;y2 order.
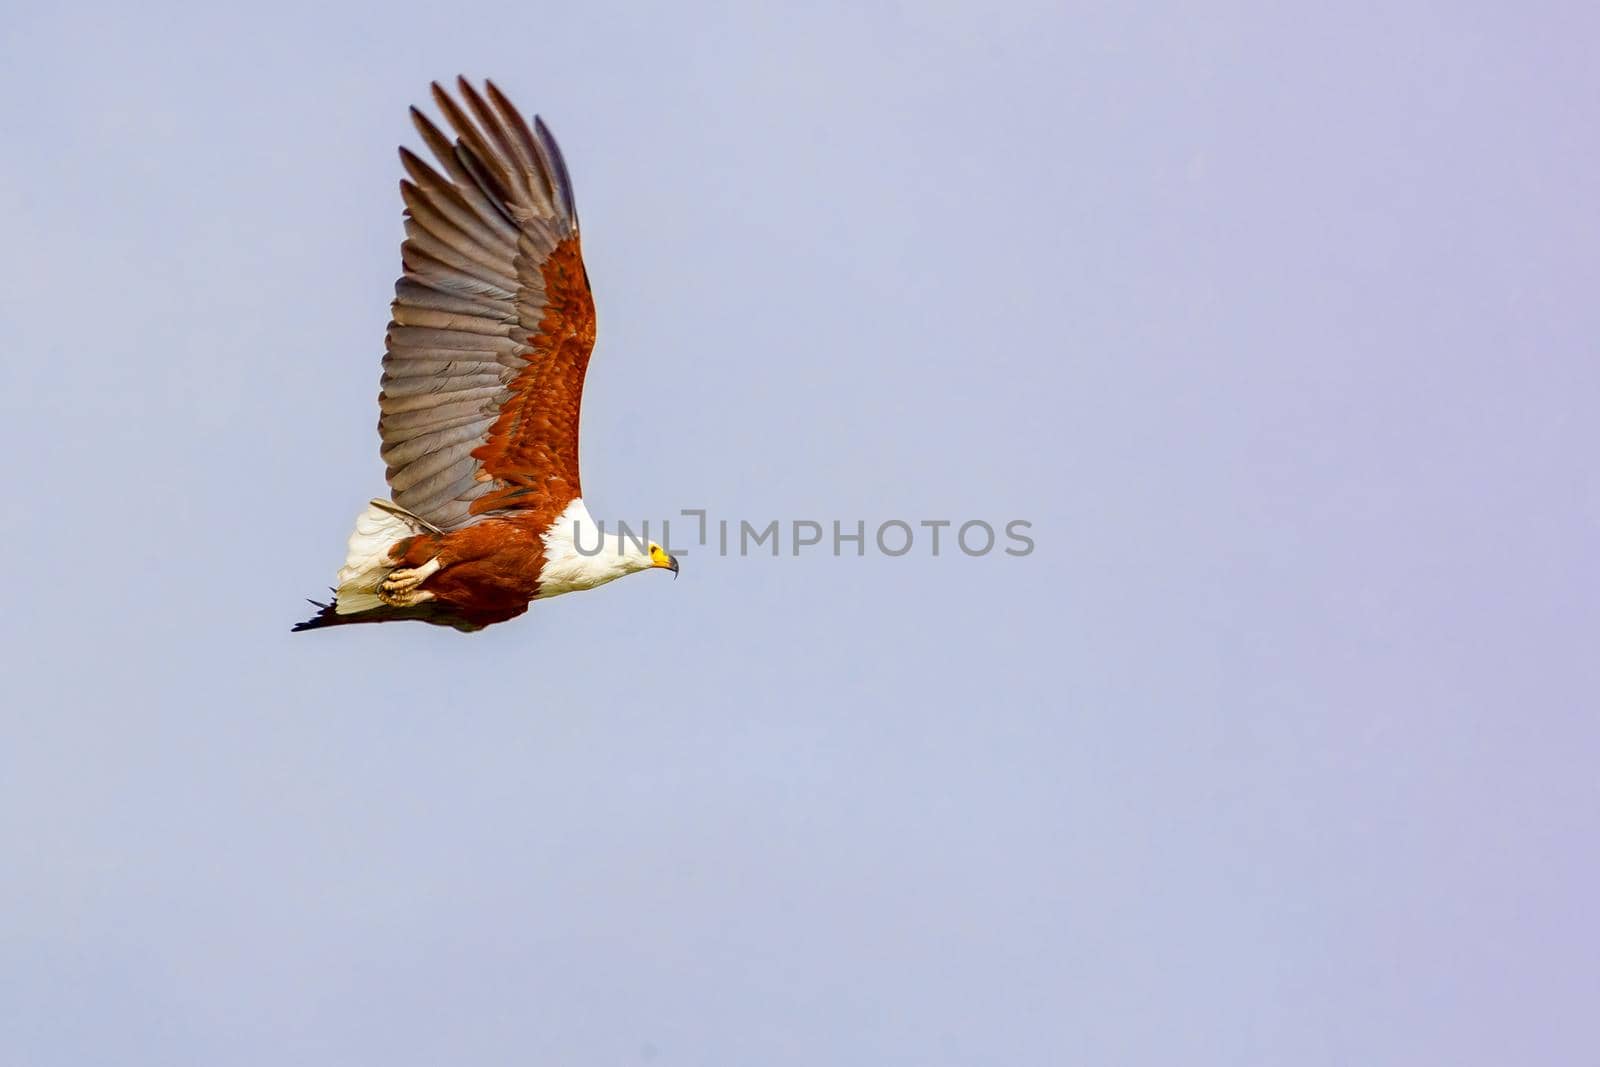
378;78;595;530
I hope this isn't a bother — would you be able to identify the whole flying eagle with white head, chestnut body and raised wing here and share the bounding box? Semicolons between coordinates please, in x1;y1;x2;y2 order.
294;78;678;632
